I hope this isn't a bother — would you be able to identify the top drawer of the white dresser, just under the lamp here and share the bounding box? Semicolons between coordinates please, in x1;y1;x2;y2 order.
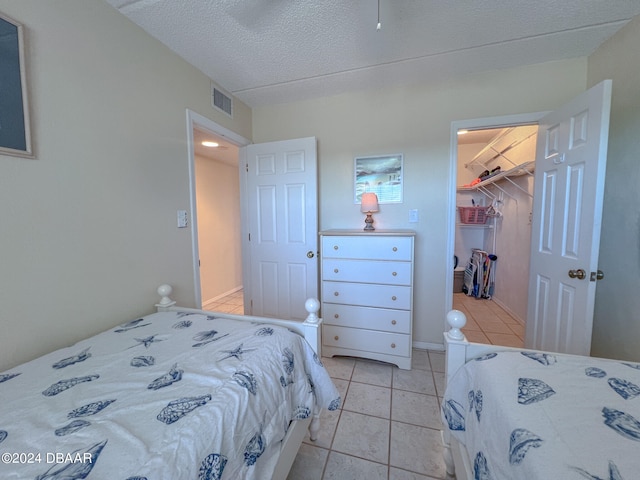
322;234;413;261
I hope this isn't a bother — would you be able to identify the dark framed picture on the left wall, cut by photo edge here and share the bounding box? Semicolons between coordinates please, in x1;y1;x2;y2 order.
0;14;33;157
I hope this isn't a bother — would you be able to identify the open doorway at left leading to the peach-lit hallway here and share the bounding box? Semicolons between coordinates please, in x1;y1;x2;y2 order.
187;112;249;314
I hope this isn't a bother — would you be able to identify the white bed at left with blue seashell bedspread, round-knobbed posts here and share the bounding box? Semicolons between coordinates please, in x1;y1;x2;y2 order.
0;285;340;480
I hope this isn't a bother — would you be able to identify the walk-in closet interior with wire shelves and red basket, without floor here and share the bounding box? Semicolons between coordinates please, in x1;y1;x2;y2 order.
454;125;537;323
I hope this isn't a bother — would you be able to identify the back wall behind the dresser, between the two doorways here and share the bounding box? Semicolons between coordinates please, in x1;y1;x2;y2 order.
253;58;586;345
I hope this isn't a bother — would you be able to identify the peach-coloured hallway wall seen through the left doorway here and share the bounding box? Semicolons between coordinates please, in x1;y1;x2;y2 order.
195;156;242;305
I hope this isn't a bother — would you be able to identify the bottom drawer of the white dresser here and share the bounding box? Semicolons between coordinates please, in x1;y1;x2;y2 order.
322;325;411;357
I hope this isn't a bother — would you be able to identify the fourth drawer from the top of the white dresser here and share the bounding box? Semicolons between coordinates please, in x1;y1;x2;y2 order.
322;303;411;334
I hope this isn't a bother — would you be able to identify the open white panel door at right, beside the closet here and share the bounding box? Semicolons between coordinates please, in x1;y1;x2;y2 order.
525;80;611;355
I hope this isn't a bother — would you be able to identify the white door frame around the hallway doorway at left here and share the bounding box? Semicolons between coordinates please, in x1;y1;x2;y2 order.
187;109;251;308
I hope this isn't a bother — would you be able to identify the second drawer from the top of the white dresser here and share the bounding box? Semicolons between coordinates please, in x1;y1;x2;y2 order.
322;258;411;285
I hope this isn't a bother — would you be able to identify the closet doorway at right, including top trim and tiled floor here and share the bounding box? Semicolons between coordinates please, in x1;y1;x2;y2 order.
452;113;543;346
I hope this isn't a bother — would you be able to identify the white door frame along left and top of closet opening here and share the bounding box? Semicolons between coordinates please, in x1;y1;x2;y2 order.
444;112;548;324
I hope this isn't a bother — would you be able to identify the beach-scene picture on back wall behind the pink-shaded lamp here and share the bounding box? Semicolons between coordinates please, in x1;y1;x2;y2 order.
354;153;402;203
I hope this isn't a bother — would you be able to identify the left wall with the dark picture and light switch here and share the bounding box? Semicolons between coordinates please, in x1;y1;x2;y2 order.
0;0;251;371
